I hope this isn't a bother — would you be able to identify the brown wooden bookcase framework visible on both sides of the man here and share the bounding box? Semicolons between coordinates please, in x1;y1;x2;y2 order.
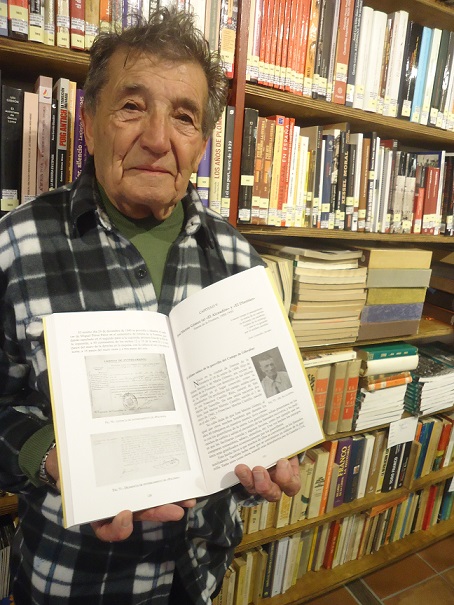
0;0;454;605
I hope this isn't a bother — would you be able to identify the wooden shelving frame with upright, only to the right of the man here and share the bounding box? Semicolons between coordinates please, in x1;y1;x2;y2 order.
230;0;454;605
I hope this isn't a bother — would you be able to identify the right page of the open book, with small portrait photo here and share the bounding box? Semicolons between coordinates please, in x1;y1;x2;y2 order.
170;267;323;492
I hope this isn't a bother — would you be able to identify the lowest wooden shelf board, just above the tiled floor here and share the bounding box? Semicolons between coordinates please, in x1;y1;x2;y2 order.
259;519;454;605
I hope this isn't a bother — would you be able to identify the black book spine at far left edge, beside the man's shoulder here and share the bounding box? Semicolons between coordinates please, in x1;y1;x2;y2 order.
0;84;24;216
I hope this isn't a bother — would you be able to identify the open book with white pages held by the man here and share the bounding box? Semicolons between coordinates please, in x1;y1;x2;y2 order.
44;267;323;527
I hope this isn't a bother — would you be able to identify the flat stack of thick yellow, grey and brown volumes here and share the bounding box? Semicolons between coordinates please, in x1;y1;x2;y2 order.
358;248;432;341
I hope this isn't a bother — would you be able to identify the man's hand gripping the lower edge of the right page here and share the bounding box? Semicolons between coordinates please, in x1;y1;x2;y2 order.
235;456;301;502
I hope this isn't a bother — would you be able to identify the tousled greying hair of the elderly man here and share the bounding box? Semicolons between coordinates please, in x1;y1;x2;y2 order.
84;6;228;139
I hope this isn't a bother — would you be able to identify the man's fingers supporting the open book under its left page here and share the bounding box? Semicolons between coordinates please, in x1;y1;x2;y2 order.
91;499;196;542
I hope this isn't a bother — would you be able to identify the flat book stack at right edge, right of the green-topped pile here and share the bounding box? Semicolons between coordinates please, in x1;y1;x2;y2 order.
404;342;454;414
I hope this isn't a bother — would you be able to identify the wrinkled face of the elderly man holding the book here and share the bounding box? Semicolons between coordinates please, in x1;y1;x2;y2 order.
83;49;208;220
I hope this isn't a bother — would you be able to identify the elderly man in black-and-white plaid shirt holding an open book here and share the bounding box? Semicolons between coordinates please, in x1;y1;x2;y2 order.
0;9;299;605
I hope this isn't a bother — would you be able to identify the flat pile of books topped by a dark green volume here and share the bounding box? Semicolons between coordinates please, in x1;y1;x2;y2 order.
353;342;419;431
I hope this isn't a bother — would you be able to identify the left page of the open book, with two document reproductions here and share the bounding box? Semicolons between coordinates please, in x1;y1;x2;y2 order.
44;311;206;525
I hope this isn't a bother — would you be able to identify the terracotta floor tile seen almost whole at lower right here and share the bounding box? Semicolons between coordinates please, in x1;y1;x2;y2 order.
363;555;434;605
